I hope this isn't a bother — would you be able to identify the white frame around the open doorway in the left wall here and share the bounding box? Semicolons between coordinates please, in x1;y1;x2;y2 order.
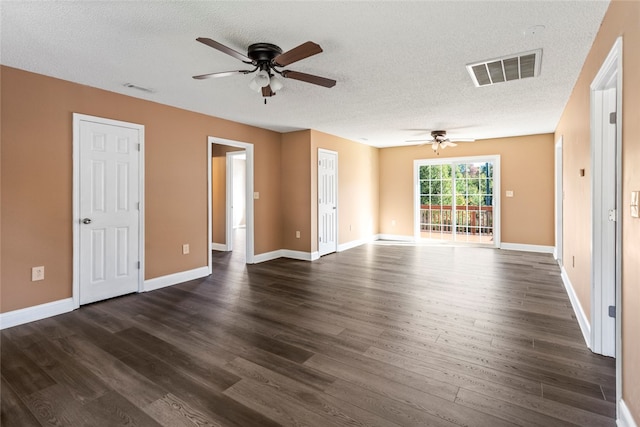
207;136;255;274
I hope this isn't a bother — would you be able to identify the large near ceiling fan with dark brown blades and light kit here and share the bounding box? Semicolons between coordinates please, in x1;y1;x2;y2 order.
193;37;336;100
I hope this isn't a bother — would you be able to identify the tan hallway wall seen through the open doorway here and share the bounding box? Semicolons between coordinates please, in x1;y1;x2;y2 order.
211;144;244;245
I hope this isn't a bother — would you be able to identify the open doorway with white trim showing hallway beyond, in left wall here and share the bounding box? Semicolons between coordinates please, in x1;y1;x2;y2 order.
207;137;254;271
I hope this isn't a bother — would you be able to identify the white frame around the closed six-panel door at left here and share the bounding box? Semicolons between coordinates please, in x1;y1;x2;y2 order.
72;113;145;308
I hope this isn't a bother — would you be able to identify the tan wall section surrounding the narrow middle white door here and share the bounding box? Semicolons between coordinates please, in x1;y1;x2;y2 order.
310;130;380;252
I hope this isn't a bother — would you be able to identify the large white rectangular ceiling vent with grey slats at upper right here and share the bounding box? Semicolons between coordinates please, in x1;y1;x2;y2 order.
467;49;542;87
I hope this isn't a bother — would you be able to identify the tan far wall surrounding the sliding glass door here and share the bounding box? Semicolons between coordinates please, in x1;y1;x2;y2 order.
380;134;554;246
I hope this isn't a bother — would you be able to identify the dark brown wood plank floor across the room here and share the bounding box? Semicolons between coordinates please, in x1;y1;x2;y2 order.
1;242;615;427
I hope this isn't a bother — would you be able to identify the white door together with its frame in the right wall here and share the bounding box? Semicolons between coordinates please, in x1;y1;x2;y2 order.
591;38;622;358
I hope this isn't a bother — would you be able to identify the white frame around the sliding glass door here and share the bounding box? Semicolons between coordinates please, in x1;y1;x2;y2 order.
413;154;501;248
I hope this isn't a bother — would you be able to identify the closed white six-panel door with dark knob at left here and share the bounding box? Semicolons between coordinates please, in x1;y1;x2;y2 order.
76;116;142;304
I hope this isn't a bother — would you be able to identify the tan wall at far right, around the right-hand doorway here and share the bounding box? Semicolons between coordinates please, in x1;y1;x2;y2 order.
556;0;640;422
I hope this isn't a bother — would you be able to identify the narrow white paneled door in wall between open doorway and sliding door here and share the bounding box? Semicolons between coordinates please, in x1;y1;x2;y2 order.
318;149;338;256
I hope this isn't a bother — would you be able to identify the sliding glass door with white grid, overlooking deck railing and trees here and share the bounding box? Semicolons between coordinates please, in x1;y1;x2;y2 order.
415;156;499;246
